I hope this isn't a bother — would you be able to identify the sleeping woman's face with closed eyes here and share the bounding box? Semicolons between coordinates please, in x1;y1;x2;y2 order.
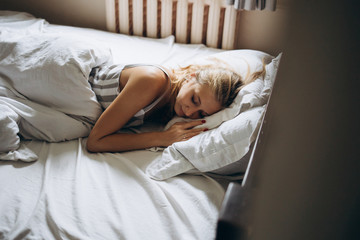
174;77;222;119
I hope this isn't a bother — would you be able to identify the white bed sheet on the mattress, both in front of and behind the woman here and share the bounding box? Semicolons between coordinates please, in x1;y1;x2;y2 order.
0;13;224;240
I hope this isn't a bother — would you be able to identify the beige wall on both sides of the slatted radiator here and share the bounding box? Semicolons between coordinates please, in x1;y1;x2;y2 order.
0;0;289;54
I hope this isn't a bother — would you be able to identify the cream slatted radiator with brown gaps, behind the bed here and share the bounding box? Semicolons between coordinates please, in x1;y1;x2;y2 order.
106;0;240;49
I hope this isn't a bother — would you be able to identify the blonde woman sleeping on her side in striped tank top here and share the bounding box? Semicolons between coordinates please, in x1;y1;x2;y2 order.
87;62;263;152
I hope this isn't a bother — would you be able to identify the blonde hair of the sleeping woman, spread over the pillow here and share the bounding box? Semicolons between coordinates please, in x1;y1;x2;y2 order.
165;59;265;120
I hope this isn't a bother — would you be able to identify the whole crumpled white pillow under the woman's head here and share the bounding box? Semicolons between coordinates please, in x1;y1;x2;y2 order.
146;50;281;180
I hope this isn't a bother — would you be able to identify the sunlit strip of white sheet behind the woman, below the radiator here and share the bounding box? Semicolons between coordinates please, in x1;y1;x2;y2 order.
43;25;224;67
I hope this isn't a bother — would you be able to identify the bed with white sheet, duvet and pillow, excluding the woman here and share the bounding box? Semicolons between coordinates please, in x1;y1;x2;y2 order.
0;7;281;239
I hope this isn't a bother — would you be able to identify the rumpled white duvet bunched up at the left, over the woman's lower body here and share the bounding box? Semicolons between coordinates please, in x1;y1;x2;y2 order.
0;14;112;161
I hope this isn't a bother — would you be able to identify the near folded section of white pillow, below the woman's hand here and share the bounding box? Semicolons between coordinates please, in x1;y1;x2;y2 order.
146;106;264;180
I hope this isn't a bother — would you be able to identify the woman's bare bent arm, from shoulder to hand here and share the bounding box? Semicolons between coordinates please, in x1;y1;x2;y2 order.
87;66;205;152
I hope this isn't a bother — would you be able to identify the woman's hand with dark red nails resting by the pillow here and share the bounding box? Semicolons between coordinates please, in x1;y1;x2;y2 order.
162;120;208;147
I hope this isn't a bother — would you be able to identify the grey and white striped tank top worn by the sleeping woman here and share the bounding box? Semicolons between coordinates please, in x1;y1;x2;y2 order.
89;64;171;127
